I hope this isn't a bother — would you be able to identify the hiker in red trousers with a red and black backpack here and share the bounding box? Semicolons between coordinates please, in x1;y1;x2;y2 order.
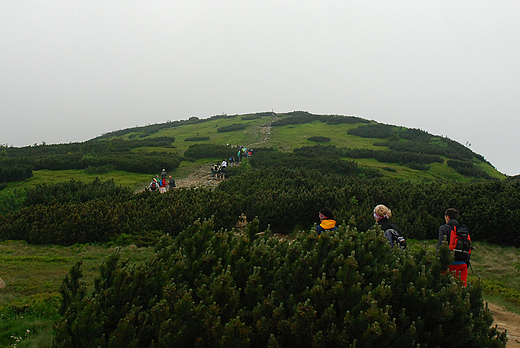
437;208;473;286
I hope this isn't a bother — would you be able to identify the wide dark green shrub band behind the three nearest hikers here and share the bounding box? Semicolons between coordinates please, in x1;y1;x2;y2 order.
0;167;520;247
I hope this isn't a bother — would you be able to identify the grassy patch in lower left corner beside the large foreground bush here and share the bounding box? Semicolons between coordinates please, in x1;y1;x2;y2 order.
0;241;153;348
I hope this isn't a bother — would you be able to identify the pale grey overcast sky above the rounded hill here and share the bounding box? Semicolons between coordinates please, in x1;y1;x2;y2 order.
0;0;520;175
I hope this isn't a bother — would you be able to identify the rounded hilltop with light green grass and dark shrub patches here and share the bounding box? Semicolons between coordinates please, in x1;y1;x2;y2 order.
93;111;505;181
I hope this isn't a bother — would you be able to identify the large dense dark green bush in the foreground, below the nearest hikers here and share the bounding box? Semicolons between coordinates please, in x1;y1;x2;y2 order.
53;221;506;348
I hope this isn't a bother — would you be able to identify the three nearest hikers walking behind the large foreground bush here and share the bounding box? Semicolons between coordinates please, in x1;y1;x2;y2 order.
316;204;473;286
